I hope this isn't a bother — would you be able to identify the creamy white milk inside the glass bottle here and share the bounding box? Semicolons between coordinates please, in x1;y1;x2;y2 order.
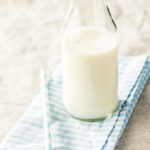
62;27;118;119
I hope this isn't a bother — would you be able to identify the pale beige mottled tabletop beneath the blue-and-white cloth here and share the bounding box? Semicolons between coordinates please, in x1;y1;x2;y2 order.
0;0;150;150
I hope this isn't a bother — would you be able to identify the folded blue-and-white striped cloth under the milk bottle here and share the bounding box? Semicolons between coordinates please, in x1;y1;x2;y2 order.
0;55;150;150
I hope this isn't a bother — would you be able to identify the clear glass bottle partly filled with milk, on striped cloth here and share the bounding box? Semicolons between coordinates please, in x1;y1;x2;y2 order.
61;0;118;121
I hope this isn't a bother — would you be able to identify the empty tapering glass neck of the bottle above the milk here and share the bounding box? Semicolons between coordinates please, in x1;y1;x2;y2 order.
61;0;116;37
